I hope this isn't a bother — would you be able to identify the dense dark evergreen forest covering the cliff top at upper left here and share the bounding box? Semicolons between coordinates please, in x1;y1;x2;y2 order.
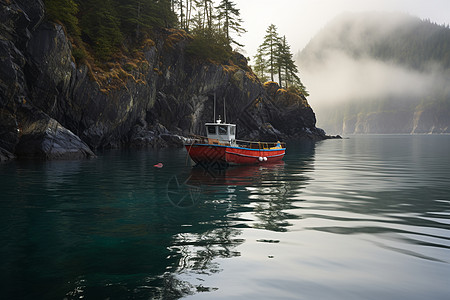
44;0;245;61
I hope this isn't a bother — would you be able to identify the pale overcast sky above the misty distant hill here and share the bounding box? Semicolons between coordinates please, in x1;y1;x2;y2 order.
232;0;450;59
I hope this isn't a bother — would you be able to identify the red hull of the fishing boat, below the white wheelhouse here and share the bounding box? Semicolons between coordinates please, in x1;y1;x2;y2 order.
185;144;286;165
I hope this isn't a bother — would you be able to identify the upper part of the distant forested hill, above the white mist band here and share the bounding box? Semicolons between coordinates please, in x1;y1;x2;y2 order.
300;13;450;70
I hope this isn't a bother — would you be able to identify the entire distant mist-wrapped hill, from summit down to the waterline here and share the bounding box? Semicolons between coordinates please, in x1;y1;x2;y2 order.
297;12;450;133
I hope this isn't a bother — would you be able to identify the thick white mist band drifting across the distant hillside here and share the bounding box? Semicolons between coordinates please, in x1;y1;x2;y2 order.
301;51;448;110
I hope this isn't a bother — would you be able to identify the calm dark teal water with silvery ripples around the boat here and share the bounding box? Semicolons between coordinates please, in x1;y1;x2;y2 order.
0;135;450;300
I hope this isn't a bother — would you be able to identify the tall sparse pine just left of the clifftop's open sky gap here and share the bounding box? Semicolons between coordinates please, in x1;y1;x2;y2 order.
216;0;246;47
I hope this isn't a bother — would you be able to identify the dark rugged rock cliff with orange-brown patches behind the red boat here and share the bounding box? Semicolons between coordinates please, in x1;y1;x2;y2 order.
0;0;326;160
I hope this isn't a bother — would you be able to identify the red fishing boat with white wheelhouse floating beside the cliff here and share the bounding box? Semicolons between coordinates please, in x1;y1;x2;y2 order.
185;117;286;166
